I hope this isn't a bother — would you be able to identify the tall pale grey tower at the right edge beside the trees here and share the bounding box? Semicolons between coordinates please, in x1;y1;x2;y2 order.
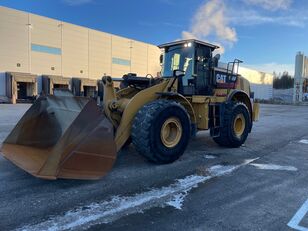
293;52;308;103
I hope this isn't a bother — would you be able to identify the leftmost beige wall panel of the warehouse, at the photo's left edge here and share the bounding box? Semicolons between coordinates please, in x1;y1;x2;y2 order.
0;7;30;72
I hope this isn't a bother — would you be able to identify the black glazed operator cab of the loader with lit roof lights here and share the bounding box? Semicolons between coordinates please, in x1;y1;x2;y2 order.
158;39;241;96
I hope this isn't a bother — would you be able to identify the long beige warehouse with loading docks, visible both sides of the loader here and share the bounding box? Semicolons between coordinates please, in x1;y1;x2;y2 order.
0;6;273;103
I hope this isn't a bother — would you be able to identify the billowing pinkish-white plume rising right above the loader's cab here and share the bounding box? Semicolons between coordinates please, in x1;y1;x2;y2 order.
182;0;237;53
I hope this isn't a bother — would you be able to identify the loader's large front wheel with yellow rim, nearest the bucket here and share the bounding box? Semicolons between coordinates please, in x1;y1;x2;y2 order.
131;100;191;164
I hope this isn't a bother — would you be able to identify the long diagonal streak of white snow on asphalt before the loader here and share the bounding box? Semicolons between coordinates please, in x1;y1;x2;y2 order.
17;159;256;231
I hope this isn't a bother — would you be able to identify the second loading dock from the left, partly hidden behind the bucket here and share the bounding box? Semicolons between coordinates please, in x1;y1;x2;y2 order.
42;75;71;95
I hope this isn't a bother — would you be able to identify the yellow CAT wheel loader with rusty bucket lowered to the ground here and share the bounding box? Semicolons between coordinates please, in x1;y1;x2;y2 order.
1;40;259;179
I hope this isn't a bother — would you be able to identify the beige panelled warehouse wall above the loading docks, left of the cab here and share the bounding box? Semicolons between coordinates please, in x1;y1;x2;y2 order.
0;7;160;79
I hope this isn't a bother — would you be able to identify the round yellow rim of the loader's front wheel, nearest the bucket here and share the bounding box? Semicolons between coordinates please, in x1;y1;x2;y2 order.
160;117;182;148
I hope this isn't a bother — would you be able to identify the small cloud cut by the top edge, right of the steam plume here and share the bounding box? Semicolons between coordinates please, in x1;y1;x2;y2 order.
243;0;292;11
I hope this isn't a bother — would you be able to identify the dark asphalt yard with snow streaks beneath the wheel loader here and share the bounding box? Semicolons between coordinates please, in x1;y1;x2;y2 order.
0;104;308;231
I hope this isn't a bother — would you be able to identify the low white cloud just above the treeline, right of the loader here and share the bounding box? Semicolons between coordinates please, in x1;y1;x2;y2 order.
243;62;295;76
